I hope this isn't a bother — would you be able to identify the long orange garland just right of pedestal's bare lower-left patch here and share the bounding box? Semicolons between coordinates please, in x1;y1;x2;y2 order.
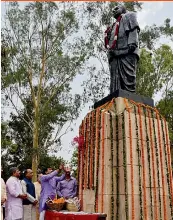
95;109;101;212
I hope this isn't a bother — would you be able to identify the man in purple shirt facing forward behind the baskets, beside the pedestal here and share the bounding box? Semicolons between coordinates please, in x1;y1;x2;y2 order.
57;169;77;199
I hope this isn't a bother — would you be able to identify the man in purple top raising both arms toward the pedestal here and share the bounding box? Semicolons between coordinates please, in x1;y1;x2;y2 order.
39;165;65;220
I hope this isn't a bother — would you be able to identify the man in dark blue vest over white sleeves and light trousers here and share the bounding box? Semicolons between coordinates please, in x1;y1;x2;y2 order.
21;169;38;220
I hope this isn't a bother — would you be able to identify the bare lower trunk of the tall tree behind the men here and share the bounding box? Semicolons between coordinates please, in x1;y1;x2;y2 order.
32;105;39;182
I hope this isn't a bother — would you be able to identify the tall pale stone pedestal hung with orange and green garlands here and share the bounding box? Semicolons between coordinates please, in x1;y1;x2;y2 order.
78;97;173;220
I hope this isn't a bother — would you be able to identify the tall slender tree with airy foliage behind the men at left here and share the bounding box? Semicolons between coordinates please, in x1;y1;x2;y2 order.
2;2;90;180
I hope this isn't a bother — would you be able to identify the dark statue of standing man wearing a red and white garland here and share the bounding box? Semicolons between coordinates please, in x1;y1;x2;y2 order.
105;5;140;93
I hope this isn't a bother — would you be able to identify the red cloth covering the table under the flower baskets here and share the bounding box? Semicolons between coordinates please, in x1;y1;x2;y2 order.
45;211;106;220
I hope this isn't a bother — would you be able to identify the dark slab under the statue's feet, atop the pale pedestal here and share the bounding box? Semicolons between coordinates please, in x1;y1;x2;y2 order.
94;89;154;109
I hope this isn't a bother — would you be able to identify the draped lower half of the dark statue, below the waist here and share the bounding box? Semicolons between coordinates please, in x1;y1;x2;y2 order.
110;54;137;93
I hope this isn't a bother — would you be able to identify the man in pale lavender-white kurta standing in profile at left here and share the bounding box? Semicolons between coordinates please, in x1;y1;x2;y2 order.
5;167;27;220
